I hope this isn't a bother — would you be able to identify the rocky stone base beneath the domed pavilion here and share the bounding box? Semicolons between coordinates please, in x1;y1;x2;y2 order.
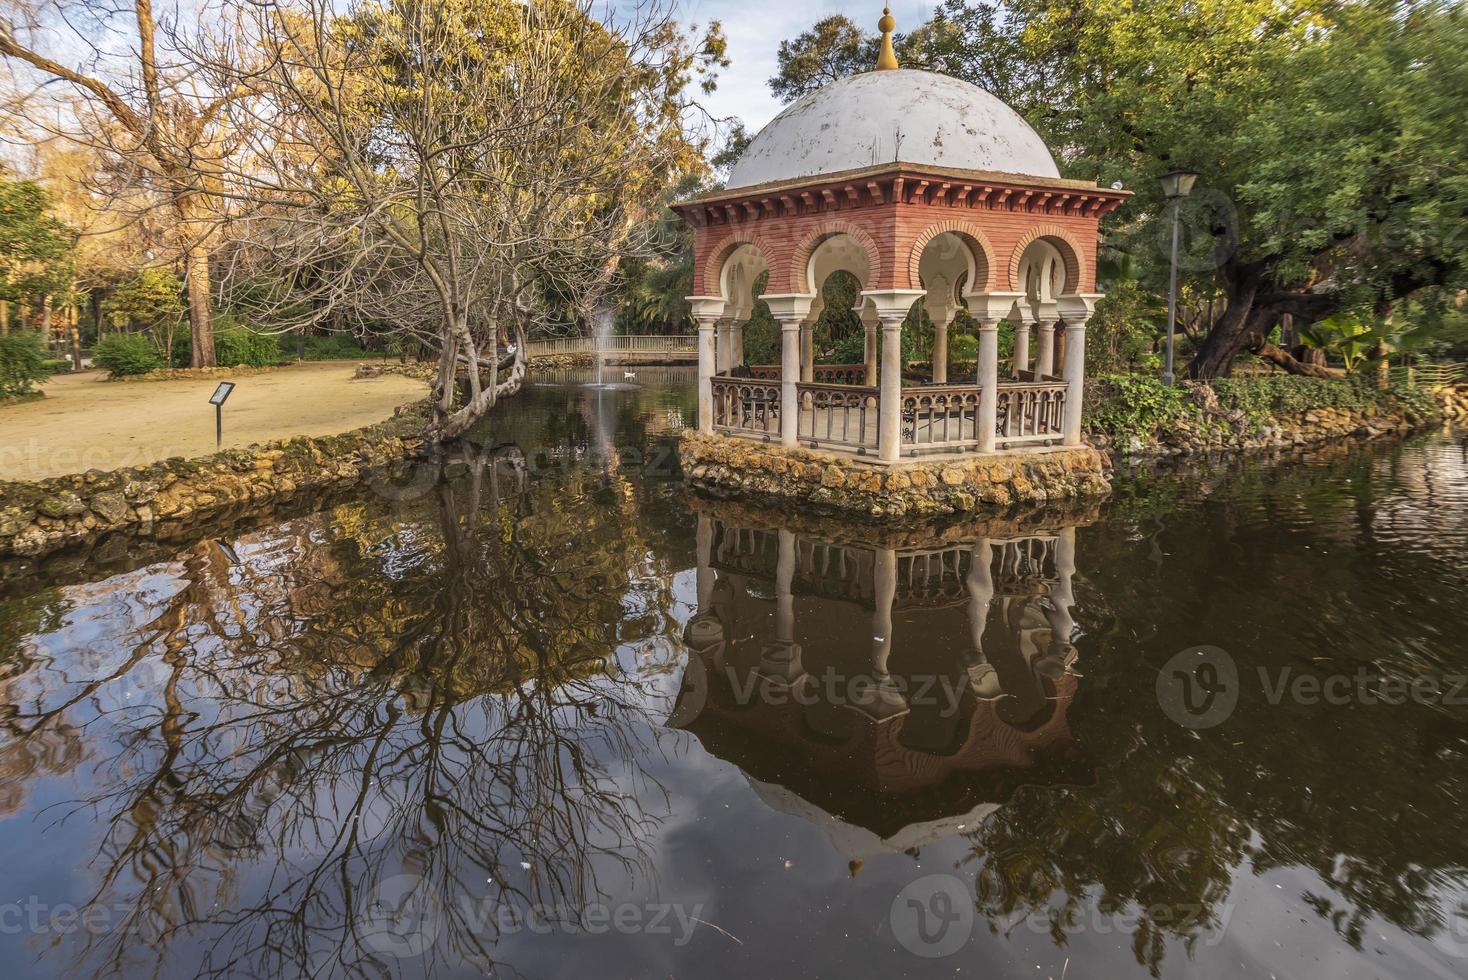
678;433;1111;519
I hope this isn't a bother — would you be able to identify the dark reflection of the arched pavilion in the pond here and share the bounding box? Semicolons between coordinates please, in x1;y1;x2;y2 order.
677;502;1092;854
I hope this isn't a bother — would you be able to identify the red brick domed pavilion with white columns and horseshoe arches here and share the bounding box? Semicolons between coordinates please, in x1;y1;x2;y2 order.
677;12;1129;481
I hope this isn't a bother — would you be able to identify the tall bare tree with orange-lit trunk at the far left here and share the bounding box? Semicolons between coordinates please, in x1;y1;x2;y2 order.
0;0;245;367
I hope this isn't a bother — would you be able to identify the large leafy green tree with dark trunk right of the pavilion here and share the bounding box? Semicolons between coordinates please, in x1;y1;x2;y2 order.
1014;0;1468;377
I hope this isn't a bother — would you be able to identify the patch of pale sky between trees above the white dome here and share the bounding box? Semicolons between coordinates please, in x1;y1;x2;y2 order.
680;0;935;132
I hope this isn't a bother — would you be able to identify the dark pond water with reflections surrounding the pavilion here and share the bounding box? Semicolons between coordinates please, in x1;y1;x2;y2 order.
0;368;1468;980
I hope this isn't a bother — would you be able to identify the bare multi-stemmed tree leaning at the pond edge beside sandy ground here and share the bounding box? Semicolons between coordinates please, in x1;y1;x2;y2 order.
195;0;721;443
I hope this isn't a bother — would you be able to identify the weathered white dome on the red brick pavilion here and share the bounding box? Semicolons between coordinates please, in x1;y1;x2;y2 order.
728;69;1060;188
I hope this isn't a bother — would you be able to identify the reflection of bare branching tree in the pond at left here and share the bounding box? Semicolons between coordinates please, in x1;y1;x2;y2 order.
9;450;681;976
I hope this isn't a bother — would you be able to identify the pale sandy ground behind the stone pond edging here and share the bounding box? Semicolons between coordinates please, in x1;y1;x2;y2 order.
0;361;427;480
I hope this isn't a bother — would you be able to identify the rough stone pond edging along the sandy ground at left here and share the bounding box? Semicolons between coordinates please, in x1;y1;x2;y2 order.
0;403;424;559
